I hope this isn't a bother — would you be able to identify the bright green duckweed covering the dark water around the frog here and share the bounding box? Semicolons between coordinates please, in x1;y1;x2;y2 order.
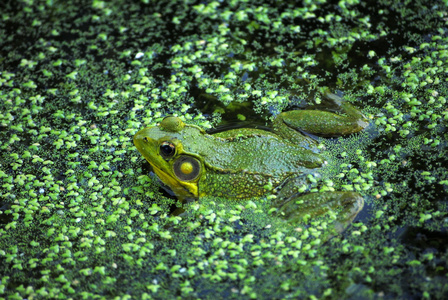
0;0;448;299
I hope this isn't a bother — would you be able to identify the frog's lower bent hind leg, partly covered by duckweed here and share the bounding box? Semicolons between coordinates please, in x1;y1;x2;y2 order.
277;192;364;234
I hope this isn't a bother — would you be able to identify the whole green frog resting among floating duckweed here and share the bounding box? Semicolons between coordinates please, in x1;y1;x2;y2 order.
133;92;369;233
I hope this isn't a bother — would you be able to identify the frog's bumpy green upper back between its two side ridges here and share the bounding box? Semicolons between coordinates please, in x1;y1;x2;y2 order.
189;128;323;174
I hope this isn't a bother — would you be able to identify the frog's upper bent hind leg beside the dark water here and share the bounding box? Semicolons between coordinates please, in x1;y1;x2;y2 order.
274;93;369;136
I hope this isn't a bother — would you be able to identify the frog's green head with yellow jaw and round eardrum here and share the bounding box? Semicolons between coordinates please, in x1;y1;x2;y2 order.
134;117;205;201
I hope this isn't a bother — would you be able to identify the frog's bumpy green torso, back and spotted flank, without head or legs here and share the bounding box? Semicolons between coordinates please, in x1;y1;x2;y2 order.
187;128;324;199
